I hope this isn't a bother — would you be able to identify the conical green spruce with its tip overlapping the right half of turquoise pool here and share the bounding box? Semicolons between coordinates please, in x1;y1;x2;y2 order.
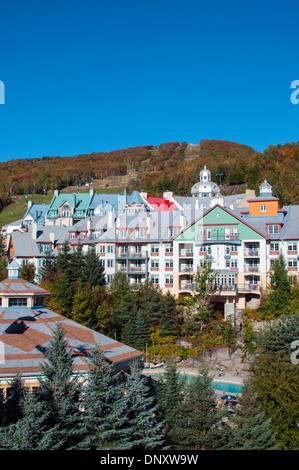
175;368;230;450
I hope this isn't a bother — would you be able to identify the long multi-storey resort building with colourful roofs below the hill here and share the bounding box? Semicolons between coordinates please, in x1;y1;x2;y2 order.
2;171;299;315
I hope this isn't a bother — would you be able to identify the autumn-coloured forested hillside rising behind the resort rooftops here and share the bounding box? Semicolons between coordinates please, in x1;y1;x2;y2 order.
0;140;299;207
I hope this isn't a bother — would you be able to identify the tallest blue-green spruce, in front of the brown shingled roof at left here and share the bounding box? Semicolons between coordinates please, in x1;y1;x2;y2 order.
38;323;82;450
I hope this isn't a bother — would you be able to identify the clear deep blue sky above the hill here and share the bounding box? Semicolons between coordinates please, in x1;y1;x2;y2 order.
0;0;299;161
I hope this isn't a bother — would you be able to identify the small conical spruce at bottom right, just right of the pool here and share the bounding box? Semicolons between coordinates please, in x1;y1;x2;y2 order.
230;381;277;450
